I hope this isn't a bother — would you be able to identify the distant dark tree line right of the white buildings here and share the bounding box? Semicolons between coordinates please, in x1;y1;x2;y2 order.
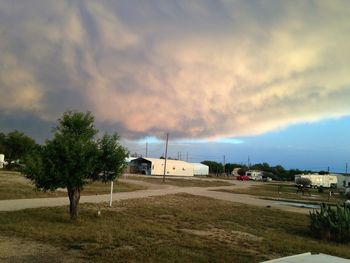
201;161;312;181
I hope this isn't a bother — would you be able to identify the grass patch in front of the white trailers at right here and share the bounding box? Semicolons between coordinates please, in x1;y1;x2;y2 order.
217;183;345;203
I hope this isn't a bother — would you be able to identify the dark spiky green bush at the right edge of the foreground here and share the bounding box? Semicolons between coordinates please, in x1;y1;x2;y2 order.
310;203;350;243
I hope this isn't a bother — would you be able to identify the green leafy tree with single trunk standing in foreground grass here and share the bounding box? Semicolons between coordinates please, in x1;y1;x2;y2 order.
23;111;127;220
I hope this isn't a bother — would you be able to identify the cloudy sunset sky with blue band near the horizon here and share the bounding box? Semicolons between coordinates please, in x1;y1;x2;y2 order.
0;0;350;171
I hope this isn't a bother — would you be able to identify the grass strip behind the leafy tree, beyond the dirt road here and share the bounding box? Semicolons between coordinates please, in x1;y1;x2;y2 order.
0;171;145;200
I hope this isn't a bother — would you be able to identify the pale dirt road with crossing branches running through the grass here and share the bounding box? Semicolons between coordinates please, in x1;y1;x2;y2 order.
0;178;309;216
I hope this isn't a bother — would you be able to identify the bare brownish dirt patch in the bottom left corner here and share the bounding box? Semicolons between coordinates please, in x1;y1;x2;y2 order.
0;236;83;263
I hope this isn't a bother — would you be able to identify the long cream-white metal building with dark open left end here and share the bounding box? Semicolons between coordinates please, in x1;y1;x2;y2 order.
130;157;193;176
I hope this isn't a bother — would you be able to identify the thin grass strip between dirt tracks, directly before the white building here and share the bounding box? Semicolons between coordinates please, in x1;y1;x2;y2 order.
127;176;232;187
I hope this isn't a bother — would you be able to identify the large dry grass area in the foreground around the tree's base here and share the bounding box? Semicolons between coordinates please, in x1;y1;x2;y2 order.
0;194;350;262
